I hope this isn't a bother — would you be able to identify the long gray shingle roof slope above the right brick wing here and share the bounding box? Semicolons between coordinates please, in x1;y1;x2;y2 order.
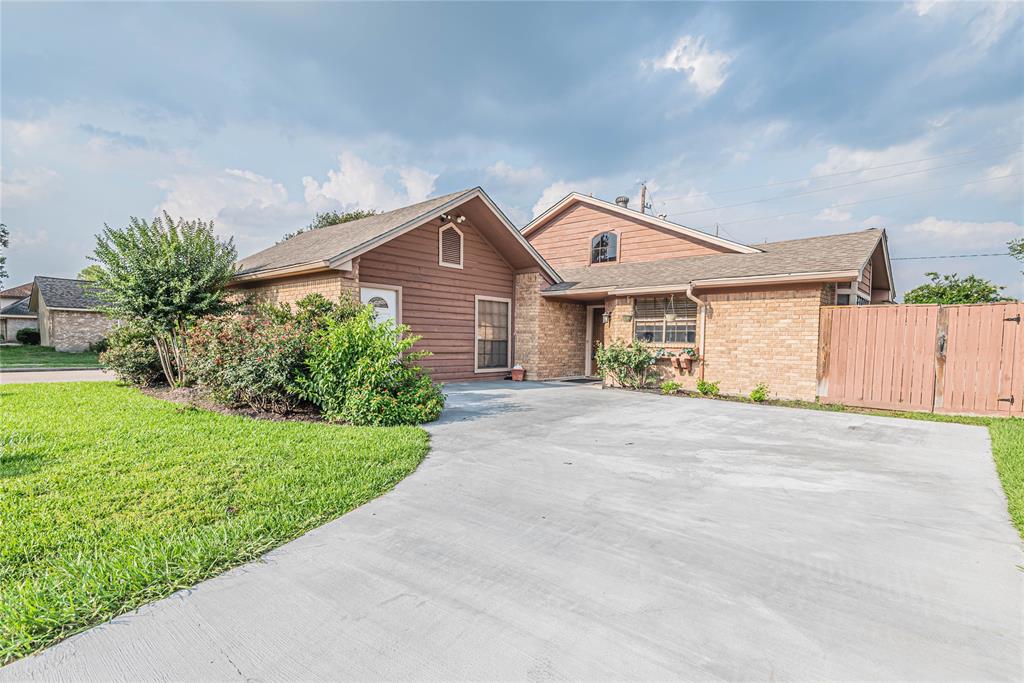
545;228;884;293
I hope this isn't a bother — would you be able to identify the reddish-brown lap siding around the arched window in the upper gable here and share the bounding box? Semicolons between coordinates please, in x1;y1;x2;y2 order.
529;204;729;269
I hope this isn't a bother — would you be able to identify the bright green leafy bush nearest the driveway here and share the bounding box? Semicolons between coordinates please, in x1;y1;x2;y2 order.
295;306;444;426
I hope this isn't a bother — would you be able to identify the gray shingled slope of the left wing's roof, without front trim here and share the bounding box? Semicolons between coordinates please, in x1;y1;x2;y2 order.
236;188;473;275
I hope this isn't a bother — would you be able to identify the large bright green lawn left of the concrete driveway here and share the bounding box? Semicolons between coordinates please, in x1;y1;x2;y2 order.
0;382;428;664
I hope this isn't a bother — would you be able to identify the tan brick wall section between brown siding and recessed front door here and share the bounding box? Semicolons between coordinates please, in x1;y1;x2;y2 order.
514;272;587;380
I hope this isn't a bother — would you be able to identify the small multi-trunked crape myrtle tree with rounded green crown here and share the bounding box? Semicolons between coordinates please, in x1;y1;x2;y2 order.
90;211;238;386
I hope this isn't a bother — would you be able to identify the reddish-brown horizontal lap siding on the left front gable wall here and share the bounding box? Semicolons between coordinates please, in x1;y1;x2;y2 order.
359;221;513;382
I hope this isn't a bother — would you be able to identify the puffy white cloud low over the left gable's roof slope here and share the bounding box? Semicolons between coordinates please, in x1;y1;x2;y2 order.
302;152;437;211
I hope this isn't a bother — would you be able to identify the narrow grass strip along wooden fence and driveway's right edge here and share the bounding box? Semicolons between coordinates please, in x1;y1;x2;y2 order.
651;385;1024;541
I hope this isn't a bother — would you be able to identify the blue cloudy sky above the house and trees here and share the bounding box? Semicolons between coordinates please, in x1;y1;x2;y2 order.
0;2;1024;297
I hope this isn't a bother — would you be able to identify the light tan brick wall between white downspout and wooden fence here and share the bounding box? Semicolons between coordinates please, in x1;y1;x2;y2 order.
700;286;829;400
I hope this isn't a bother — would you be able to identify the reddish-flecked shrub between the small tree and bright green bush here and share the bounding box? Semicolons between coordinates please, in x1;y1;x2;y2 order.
188;294;361;413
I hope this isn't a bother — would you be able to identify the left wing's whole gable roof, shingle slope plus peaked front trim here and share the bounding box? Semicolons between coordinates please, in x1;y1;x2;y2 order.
236;187;560;283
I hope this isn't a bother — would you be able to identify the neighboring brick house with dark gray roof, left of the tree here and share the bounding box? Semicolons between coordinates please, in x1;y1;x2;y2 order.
29;275;113;351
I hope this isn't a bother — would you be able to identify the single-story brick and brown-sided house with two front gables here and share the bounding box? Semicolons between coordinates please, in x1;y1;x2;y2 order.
232;187;893;399
